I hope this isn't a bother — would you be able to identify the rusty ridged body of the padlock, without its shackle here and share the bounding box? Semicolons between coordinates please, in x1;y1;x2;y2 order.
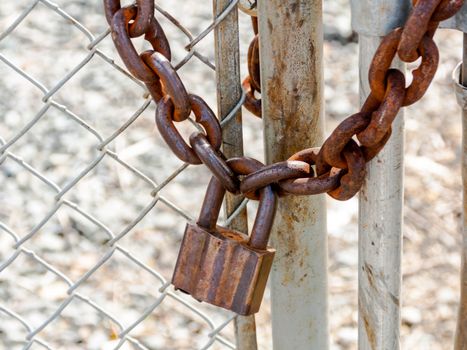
172;223;275;315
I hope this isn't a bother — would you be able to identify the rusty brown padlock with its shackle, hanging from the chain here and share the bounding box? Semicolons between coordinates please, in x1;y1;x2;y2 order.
172;177;276;315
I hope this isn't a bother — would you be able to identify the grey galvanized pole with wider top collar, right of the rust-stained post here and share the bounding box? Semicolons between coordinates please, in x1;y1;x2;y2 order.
351;0;410;350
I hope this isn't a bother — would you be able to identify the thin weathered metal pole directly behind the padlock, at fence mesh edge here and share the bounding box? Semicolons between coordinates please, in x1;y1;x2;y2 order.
213;0;257;350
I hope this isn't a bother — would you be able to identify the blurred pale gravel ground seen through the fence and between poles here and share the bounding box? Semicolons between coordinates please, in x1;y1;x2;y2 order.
0;0;462;350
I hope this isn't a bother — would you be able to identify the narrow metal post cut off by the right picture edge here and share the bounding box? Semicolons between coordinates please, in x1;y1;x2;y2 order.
442;3;467;350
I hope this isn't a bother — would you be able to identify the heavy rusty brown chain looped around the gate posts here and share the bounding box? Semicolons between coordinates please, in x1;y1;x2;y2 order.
104;0;463;208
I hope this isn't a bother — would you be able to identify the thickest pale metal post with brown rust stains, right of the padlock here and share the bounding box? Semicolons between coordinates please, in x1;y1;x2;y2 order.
258;0;329;350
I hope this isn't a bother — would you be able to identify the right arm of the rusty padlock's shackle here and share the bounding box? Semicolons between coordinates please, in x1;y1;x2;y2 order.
248;186;277;250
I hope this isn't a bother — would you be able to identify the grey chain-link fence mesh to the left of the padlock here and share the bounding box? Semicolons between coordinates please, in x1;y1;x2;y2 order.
0;0;252;349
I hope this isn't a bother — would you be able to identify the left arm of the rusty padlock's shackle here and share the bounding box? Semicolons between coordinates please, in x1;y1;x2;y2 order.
197;176;225;231
